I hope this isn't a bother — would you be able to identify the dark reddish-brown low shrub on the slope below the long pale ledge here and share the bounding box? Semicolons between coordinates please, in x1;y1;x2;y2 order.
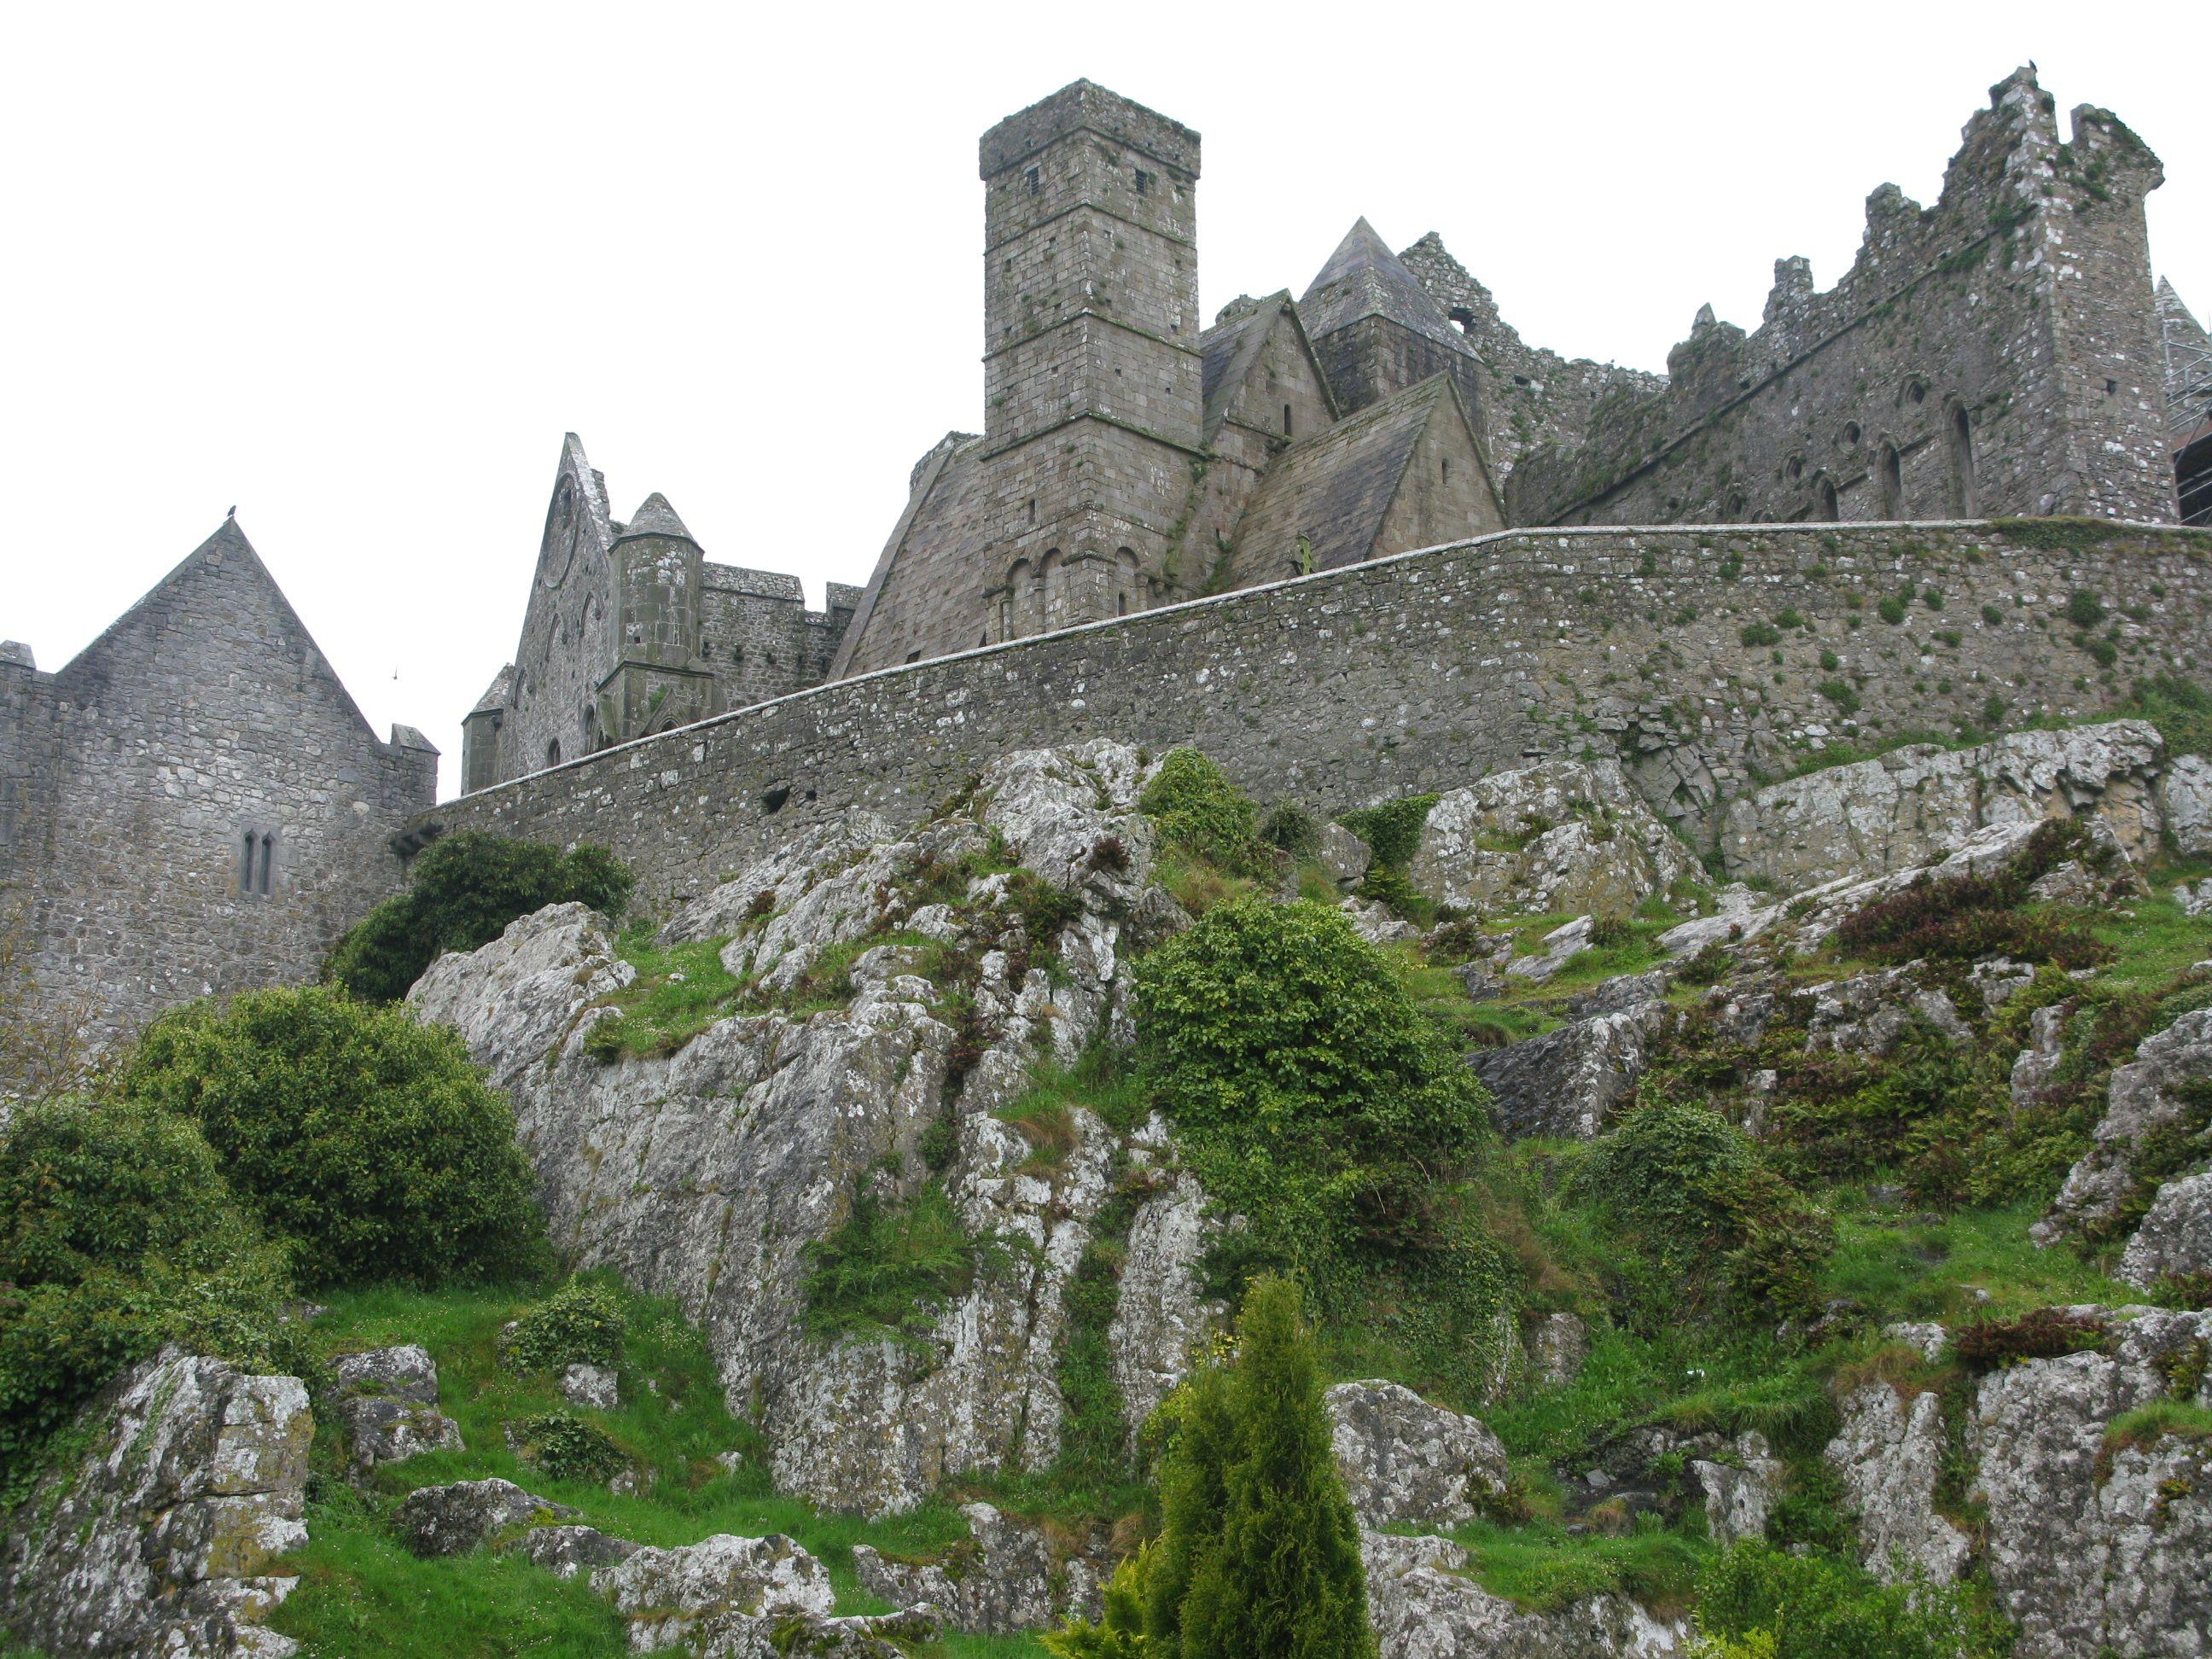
1836;818;2112;969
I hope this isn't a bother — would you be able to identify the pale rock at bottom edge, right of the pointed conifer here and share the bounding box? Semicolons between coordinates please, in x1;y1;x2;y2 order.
1360;1531;1690;1659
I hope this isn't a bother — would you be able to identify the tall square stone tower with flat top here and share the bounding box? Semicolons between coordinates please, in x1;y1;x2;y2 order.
982;79;1206;639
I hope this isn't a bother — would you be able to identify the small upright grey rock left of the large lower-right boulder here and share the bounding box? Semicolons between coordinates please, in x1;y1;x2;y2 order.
1827;1382;1969;1584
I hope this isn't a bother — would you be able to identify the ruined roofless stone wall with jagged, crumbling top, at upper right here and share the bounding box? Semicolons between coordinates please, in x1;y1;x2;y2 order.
1506;68;2174;524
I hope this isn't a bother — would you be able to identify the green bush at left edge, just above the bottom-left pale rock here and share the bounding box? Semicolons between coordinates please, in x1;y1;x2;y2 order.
0;1099;311;1498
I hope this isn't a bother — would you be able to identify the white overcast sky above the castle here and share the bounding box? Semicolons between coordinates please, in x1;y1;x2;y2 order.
0;0;2212;788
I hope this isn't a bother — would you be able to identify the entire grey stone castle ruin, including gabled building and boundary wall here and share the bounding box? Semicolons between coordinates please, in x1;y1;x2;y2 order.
0;71;2212;1044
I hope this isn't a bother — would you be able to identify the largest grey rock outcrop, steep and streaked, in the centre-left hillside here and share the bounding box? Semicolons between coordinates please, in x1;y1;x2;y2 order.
411;743;1195;1516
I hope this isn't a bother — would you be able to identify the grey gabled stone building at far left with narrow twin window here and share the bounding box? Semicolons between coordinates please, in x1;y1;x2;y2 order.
0;522;438;1038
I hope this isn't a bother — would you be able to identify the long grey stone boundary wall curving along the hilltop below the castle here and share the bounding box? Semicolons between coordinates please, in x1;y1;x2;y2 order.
414;520;2212;909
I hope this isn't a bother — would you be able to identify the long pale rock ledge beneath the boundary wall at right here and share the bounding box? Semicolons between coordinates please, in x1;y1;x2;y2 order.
1721;721;2166;892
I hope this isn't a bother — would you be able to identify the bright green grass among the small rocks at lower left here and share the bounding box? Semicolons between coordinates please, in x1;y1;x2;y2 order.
272;1288;1039;1659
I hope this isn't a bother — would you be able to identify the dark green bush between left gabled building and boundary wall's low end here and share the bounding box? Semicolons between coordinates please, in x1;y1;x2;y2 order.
323;830;632;1002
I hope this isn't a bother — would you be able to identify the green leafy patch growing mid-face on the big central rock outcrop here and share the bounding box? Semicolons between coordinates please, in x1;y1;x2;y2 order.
805;1179;1004;1341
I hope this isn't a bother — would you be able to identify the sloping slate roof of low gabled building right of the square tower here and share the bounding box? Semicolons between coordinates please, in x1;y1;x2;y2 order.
1237;374;1464;571
